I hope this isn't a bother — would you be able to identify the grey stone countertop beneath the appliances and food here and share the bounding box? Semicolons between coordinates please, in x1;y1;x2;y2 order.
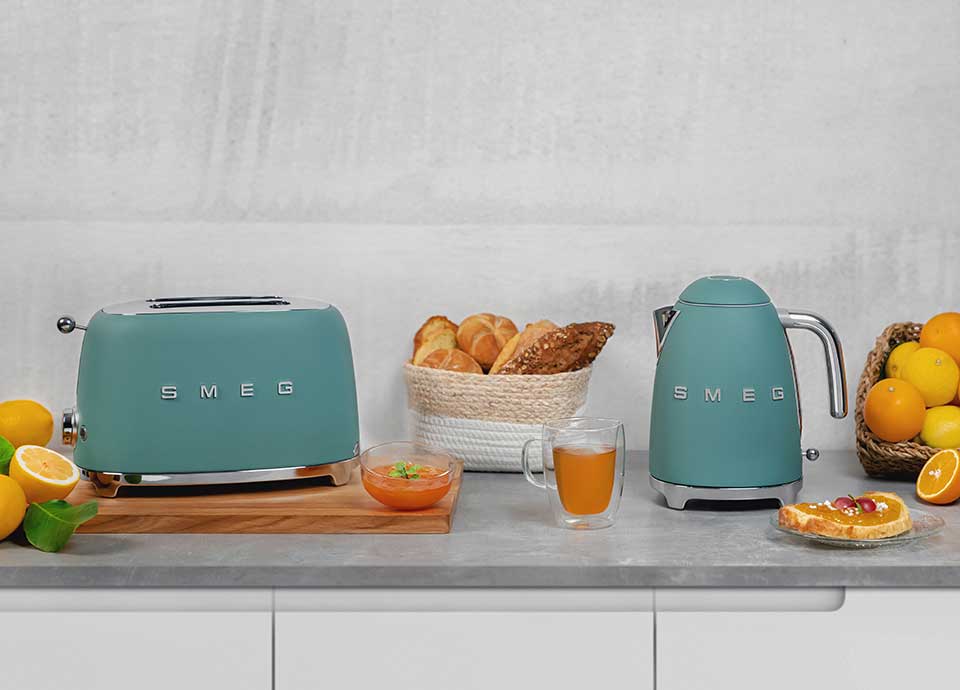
0;452;960;587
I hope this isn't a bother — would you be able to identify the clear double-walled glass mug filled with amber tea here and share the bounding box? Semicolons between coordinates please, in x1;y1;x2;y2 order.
521;417;626;529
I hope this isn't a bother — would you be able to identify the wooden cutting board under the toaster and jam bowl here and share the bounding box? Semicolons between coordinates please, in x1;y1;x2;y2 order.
67;469;463;534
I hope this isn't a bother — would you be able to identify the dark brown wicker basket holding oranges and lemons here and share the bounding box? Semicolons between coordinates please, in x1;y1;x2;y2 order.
856;321;939;480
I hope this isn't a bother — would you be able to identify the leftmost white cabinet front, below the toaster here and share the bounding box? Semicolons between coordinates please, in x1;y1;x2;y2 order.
0;589;272;690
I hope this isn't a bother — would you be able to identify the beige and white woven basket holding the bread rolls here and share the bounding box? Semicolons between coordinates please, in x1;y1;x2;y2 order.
403;362;592;472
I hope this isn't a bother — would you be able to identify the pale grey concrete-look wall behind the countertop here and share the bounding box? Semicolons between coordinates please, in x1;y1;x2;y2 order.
0;0;960;448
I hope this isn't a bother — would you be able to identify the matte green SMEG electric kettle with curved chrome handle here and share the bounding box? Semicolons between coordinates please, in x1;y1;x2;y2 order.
650;276;847;509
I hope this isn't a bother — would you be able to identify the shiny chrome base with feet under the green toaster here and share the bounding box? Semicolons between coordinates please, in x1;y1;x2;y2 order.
80;457;360;498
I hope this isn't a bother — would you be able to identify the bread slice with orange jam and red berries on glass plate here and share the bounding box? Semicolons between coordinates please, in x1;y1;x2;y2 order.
778;491;913;539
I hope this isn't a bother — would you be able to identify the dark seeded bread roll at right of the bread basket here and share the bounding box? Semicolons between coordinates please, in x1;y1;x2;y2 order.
499;321;614;374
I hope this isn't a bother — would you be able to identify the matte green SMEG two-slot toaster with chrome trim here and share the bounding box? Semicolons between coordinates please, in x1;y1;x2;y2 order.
57;296;359;496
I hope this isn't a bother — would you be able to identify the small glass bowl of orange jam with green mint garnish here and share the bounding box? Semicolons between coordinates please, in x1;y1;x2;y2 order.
360;441;461;510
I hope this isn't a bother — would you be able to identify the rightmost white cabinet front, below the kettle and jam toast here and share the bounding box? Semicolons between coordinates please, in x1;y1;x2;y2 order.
656;589;960;690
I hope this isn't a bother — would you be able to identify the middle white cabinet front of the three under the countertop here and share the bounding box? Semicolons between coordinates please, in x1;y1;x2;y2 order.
275;589;653;690
